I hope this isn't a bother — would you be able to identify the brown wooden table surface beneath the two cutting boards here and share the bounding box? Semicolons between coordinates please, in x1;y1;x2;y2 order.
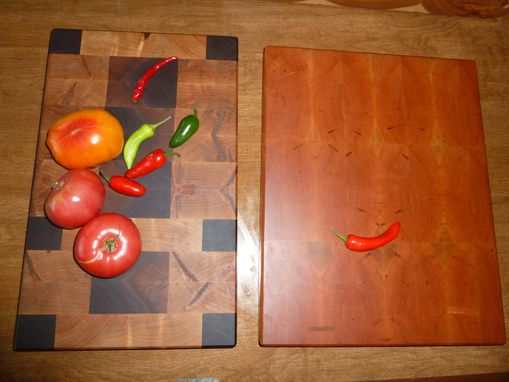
0;0;509;381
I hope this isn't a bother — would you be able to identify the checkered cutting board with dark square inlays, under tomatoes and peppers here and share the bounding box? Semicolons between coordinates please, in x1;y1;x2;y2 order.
14;29;237;350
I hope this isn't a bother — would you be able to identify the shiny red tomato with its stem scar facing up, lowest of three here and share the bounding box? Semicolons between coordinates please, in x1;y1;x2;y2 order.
74;213;141;278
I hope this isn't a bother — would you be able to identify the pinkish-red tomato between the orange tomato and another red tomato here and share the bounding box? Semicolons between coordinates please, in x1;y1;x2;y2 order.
44;169;105;229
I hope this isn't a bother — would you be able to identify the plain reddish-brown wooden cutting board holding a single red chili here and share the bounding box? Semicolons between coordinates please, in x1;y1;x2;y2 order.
260;47;505;346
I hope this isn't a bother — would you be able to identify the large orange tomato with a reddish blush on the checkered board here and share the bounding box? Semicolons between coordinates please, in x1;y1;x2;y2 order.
46;109;124;169
